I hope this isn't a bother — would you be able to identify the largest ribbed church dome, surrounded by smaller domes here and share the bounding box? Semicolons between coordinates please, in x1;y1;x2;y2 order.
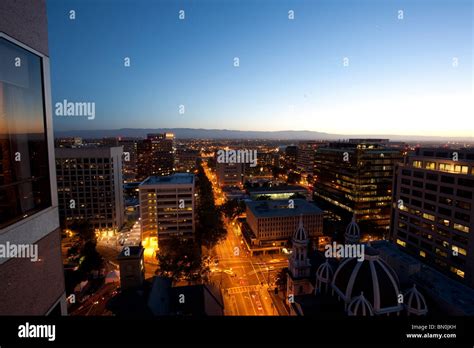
331;246;403;314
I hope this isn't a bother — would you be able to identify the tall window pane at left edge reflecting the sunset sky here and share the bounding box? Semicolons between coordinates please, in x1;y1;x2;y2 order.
0;38;51;228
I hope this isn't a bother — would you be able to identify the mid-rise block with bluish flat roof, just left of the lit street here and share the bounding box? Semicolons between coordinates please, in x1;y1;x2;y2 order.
139;173;195;243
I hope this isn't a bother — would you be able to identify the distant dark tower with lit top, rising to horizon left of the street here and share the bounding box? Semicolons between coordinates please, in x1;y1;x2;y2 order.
137;133;176;181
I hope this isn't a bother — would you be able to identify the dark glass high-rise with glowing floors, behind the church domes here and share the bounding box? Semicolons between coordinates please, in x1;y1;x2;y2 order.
314;139;403;233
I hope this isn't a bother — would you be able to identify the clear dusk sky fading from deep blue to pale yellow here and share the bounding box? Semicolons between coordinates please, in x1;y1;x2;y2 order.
47;0;474;137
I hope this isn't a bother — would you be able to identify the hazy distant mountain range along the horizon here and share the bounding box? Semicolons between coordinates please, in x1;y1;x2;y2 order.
55;128;474;142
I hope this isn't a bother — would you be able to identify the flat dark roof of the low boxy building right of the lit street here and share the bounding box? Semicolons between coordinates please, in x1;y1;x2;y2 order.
246;199;323;217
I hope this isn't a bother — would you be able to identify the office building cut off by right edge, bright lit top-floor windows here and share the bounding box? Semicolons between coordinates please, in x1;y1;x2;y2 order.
391;148;474;287
